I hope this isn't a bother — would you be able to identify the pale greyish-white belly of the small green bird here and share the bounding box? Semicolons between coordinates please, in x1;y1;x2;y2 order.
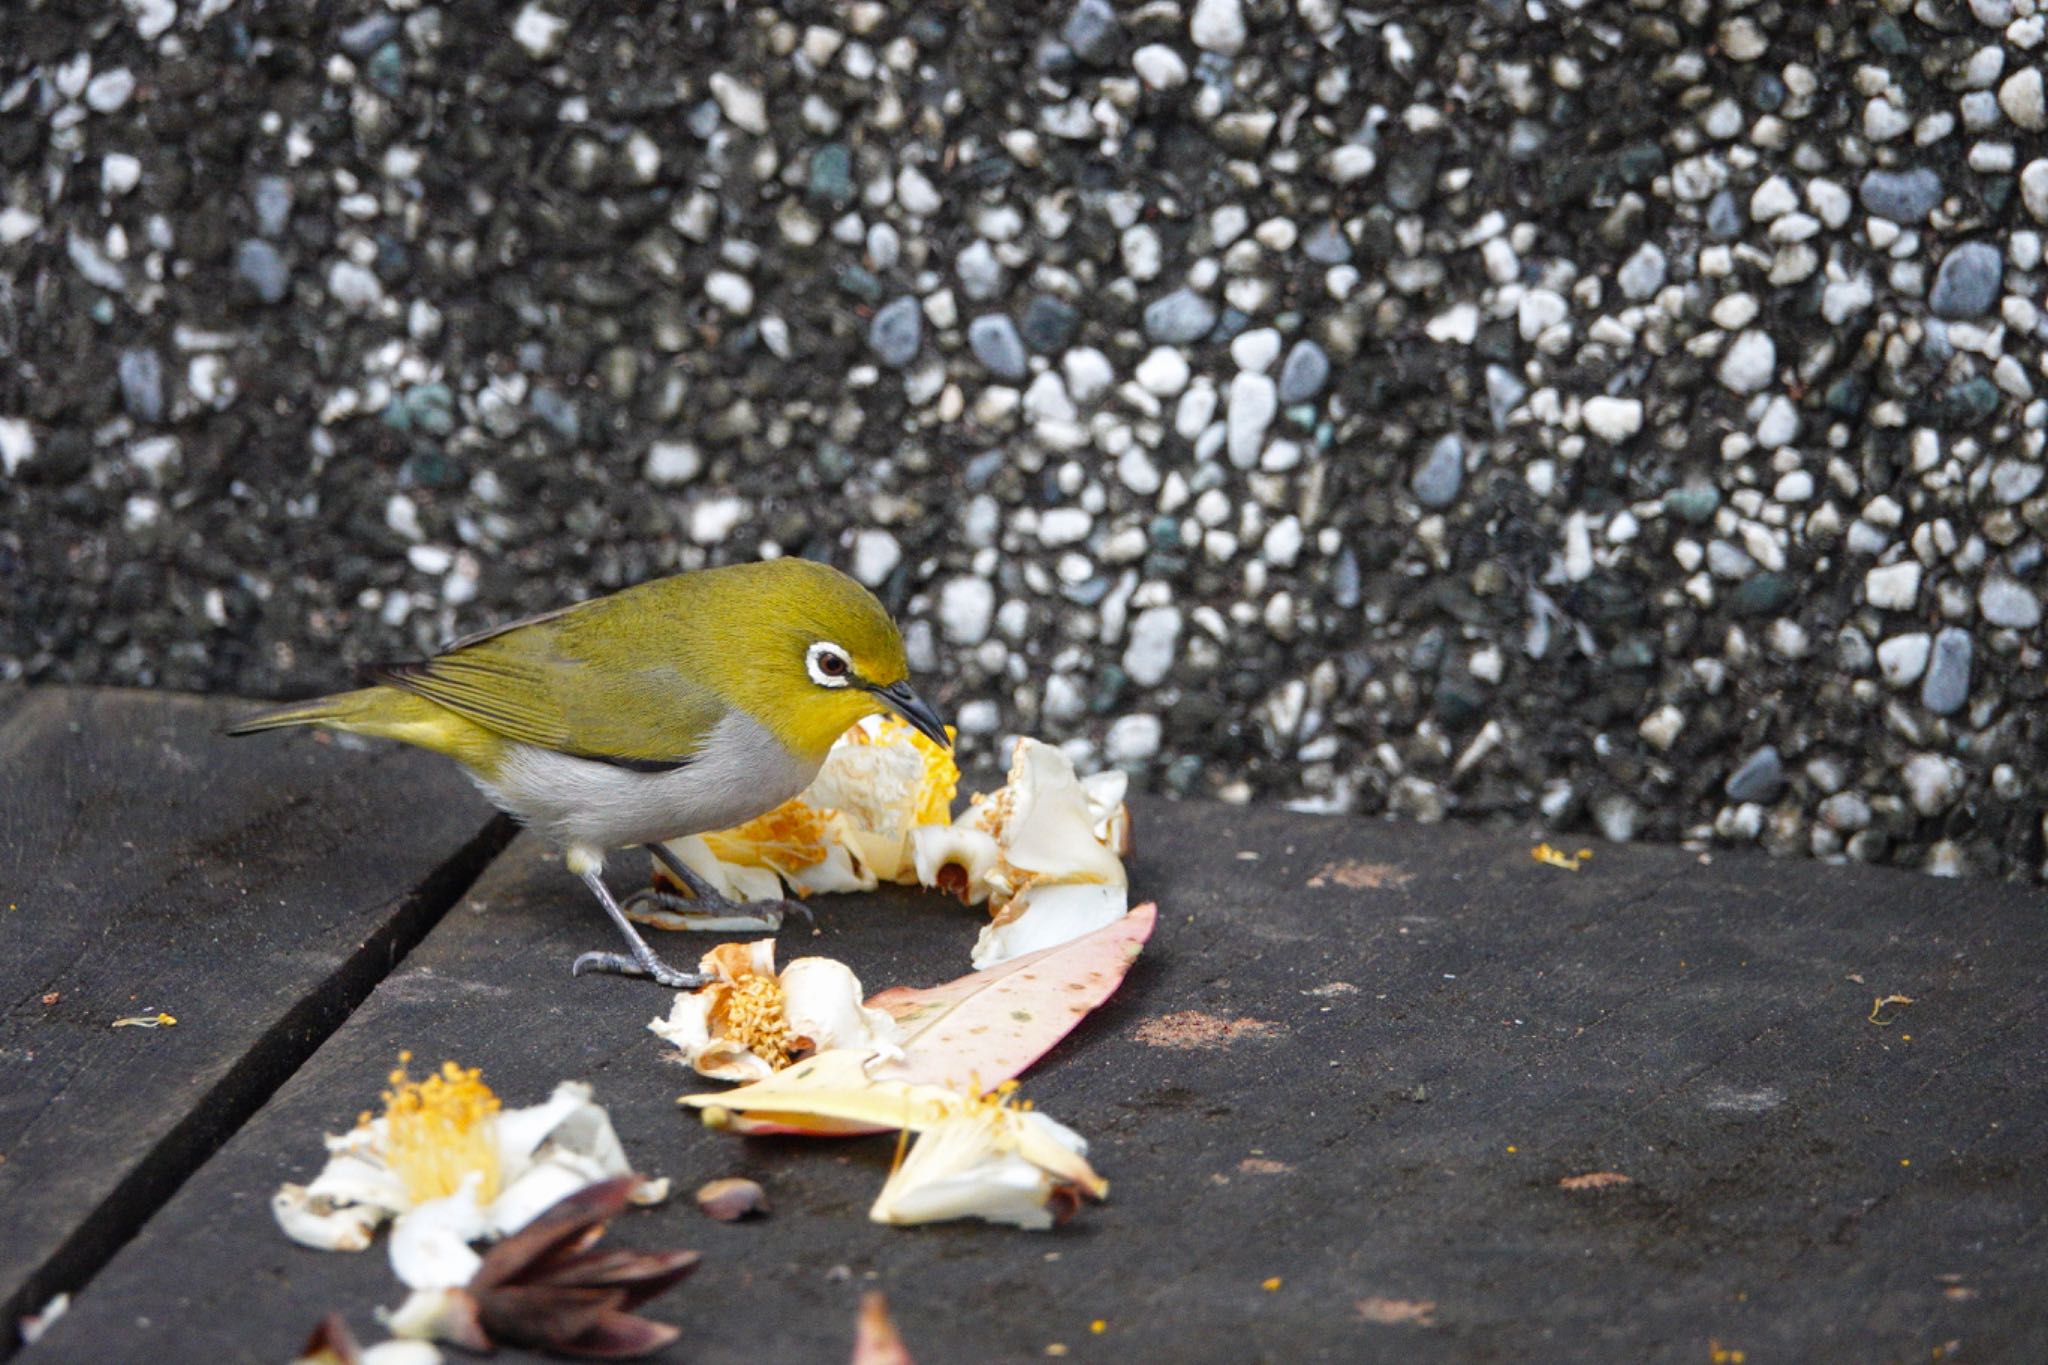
477;712;819;853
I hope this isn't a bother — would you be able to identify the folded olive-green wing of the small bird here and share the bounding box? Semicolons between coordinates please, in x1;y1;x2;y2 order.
373;598;727;772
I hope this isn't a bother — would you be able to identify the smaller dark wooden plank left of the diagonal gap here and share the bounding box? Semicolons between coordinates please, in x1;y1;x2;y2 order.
0;690;504;1351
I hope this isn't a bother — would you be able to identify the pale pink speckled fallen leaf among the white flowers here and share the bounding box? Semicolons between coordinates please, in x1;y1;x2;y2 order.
868;902;1159;1091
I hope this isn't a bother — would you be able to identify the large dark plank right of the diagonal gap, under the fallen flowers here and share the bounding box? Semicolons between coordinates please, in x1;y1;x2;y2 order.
43;802;2048;1365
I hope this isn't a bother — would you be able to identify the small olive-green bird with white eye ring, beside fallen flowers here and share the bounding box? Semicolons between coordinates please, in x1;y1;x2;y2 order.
227;559;950;988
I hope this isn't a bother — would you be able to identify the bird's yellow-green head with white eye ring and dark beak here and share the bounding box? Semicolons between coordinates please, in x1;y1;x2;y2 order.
729;559;952;759
